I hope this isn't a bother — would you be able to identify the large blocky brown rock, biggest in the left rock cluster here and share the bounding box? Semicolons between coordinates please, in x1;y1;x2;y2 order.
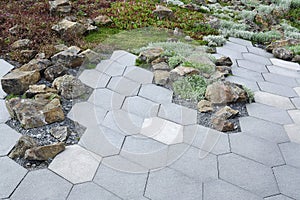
6;98;65;129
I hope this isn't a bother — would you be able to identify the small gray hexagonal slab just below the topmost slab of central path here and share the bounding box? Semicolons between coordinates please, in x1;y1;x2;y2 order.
96;60;126;76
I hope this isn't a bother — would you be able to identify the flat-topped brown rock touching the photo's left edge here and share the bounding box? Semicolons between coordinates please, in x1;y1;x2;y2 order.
1;69;41;94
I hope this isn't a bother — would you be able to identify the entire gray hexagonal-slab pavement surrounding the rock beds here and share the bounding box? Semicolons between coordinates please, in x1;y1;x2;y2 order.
0;38;300;200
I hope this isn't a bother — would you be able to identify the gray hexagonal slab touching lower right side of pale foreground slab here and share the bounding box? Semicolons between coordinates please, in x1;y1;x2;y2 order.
94;159;148;200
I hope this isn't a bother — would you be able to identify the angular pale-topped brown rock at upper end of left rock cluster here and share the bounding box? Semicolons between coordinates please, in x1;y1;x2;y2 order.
51;46;84;68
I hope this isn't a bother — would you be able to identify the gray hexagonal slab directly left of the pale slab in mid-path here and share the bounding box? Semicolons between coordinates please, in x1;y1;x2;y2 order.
102;110;144;135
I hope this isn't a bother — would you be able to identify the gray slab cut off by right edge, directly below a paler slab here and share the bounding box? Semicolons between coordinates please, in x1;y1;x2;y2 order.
279;142;300;169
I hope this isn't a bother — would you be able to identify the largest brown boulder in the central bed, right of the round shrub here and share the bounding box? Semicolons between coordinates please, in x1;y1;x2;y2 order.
205;82;248;104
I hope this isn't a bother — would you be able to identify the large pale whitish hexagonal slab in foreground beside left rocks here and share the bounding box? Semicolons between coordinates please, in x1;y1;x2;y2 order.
49;145;101;184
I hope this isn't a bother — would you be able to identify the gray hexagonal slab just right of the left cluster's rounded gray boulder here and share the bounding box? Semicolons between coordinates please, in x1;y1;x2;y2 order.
79;69;111;89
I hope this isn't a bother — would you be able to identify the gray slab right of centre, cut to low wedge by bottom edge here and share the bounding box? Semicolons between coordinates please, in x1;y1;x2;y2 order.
203;180;262;200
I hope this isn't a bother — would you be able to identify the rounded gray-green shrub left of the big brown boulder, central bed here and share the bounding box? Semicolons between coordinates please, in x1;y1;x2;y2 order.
173;75;207;101
